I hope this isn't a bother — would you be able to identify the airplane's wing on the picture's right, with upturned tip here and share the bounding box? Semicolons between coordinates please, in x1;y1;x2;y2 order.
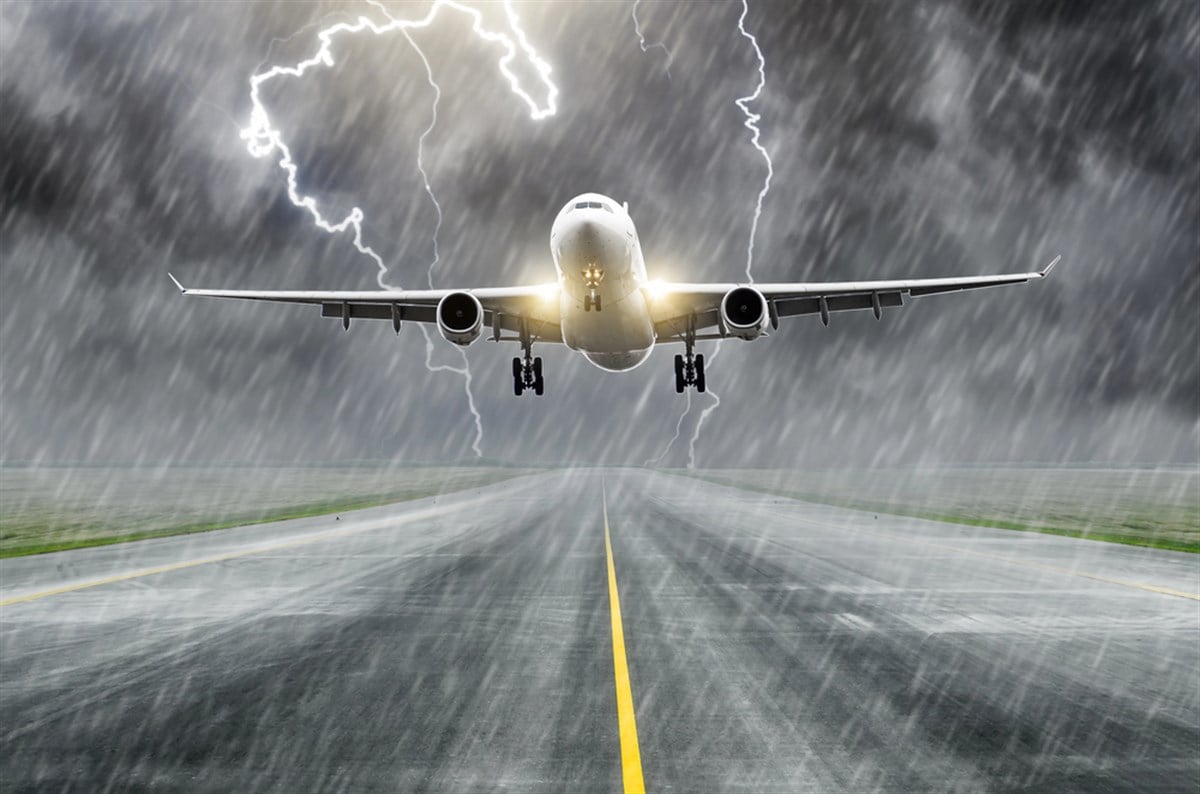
648;257;1061;342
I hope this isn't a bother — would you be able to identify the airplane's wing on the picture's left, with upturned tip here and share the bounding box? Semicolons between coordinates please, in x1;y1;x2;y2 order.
167;273;563;343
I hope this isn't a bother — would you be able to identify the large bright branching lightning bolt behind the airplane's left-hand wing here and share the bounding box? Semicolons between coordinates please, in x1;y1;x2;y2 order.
241;0;558;457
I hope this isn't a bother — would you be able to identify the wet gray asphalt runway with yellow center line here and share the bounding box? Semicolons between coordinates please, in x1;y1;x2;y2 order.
0;469;1200;793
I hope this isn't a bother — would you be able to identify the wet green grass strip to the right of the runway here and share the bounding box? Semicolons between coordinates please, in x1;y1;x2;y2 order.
679;467;1200;553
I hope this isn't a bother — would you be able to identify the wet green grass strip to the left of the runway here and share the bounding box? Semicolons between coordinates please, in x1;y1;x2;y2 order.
0;463;530;558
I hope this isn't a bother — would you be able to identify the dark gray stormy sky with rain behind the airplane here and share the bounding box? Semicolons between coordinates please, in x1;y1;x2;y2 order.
0;0;1200;467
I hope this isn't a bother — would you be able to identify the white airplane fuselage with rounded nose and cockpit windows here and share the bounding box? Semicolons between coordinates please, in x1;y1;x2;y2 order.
550;193;654;372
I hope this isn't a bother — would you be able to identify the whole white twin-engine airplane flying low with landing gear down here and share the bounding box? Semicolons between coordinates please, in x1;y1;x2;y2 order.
168;193;1061;396
